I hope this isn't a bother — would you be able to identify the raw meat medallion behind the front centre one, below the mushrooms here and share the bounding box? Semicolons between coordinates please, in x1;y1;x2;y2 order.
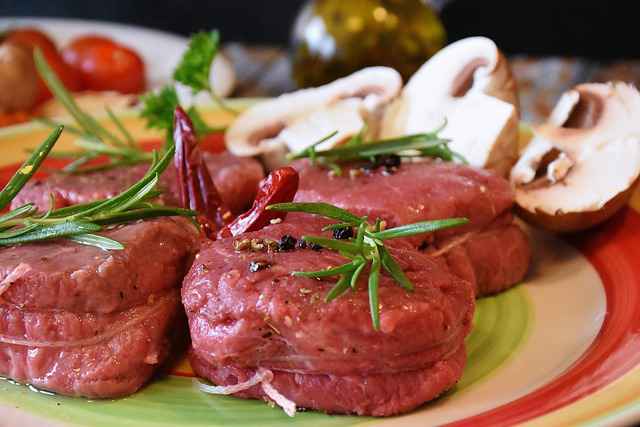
296;161;531;296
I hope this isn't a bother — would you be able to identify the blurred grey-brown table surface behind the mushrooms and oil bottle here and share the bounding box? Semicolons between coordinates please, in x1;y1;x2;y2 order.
225;44;640;123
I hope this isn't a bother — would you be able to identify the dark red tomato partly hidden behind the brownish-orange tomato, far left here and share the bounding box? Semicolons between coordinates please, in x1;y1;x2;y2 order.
5;28;83;103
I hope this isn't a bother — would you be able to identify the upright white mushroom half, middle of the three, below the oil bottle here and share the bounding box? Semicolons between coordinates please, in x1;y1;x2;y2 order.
381;37;519;176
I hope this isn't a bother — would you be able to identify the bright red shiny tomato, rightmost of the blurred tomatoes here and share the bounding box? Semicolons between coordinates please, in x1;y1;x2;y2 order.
62;36;146;93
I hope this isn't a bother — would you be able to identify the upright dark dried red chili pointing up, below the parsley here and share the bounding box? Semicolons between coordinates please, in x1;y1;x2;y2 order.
173;106;231;237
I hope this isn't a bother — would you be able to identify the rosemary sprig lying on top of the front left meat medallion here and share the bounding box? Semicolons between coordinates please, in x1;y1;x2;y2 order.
0;126;195;250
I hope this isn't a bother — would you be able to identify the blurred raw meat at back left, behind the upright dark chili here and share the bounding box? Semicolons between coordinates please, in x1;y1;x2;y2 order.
12;152;264;213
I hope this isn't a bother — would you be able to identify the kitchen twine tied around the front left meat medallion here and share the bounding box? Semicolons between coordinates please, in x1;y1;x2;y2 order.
0;292;176;348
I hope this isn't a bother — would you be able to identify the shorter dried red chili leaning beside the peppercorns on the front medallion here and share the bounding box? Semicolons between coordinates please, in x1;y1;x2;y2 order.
218;166;299;237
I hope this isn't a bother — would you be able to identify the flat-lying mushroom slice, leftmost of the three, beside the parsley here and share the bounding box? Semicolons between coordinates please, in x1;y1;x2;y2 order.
226;67;402;165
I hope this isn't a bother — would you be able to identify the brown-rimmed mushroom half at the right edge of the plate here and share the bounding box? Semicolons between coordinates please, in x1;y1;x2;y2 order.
511;82;640;232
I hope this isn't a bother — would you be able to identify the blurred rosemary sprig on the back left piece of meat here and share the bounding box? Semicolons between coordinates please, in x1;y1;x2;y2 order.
34;49;151;173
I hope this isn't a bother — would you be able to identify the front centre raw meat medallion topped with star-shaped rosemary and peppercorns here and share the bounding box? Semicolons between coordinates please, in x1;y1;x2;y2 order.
182;214;474;415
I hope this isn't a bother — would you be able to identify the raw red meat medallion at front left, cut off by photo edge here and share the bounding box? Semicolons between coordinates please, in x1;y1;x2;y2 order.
0;218;199;398
